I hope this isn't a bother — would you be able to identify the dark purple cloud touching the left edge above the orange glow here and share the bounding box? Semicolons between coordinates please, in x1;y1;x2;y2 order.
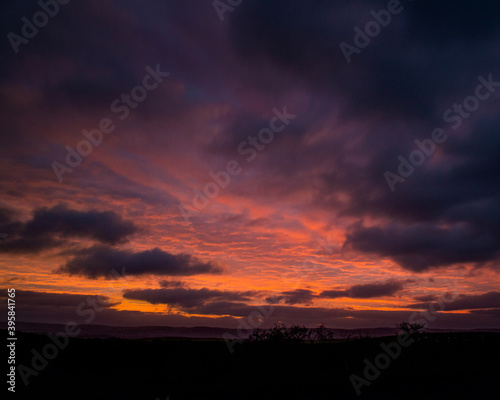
0;205;139;253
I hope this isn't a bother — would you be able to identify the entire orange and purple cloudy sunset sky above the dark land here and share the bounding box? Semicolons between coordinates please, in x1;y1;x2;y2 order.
0;0;500;329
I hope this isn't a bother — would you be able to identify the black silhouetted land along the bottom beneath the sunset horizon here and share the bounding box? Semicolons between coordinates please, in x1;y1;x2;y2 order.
2;331;500;400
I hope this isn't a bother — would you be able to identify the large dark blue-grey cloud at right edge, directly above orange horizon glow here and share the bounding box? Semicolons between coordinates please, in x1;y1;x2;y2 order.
345;119;500;272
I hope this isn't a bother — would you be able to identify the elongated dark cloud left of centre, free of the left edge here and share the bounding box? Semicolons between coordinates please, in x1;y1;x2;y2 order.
57;246;221;279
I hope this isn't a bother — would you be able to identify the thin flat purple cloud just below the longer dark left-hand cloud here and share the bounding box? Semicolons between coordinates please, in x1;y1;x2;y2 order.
123;288;252;314
